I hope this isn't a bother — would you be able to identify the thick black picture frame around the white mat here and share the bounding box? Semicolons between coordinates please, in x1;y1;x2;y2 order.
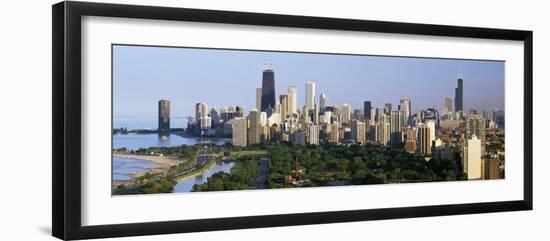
52;1;533;239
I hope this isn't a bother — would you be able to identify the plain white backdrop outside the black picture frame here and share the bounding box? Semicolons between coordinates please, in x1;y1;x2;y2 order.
0;0;550;240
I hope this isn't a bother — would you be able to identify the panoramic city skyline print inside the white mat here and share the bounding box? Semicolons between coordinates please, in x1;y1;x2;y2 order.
111;44;505;195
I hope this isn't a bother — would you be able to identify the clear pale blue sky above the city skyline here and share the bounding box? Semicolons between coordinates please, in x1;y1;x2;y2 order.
113;45;505;117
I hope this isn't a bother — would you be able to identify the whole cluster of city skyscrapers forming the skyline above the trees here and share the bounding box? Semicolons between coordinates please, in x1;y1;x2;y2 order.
159;65;504;179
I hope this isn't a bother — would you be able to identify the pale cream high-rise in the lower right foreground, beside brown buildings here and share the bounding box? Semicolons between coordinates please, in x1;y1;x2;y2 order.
462;135;482;180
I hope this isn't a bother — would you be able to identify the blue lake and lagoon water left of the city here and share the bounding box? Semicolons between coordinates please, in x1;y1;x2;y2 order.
112;117;233;192
